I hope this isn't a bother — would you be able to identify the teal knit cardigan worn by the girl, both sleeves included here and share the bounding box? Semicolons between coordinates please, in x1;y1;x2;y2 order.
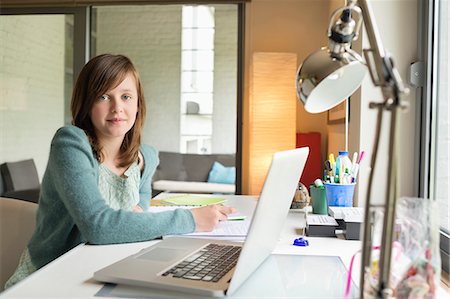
28;126;195;269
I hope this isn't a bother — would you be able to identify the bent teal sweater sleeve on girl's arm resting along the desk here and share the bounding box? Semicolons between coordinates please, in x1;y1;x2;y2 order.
49;126;195;244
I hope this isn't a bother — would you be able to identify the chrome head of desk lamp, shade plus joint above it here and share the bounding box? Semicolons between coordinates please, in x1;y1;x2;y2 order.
297;5;367;113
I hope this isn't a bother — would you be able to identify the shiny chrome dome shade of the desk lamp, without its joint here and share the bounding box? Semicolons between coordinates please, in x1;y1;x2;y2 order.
296;48;367;113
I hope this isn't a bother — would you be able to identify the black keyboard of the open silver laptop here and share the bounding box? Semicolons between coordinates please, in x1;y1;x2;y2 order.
162;244;241;282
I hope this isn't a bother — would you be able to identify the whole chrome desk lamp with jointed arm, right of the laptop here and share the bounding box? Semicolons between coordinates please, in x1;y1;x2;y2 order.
296;0;408;298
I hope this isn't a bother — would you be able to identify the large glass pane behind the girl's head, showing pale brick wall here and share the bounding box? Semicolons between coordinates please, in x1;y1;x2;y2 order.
91;4;238;154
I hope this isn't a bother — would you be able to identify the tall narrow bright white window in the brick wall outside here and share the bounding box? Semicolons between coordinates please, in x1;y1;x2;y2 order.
180;5;215;154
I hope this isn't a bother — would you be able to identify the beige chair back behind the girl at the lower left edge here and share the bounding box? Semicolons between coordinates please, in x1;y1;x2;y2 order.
0;197;38;292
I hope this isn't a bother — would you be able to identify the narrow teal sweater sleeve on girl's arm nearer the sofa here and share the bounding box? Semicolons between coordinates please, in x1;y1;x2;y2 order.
139;144;159;211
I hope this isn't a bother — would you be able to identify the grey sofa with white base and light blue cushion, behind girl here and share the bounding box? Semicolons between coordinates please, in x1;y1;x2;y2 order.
152;151;236;196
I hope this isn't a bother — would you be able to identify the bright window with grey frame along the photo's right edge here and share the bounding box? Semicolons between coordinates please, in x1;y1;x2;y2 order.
421;1;450;273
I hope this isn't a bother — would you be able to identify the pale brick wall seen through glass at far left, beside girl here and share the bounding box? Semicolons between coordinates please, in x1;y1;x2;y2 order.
0;15;65;179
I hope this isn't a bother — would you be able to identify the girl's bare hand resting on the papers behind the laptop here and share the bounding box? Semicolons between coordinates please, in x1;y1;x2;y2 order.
191;205;236;232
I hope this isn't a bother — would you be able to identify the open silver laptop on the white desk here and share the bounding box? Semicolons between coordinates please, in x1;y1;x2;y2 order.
94;147;309;297
